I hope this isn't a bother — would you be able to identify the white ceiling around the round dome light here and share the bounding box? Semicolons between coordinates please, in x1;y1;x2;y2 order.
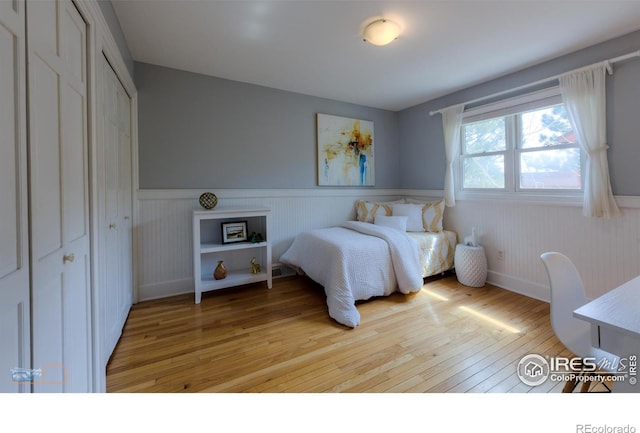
112;0;640;111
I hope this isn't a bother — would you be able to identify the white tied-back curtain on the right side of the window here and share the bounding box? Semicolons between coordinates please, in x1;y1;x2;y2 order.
559;62;620;218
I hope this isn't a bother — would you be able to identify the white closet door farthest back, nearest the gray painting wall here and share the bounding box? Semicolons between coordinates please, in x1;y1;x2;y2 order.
98;56;133;367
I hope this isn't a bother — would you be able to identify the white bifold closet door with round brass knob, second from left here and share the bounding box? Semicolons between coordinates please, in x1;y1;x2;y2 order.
27;0;92;392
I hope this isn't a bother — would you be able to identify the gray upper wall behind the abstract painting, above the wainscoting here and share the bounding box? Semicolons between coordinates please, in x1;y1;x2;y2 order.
135;62;401;189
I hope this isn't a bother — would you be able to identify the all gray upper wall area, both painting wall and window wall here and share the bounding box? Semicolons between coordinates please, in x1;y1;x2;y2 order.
135;32;640;195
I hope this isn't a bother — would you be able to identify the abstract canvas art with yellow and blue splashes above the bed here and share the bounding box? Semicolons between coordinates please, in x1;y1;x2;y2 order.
317;113;375;186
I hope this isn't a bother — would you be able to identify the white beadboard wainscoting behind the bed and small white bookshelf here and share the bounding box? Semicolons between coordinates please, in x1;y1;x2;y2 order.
136;188;416;301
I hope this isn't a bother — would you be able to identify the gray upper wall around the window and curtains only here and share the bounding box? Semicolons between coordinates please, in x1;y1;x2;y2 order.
398;28;640;195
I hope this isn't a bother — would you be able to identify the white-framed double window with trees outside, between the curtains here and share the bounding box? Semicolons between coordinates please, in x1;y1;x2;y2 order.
459;89;583;194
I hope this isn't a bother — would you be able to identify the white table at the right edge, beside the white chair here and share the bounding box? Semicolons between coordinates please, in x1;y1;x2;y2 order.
573;276;640;392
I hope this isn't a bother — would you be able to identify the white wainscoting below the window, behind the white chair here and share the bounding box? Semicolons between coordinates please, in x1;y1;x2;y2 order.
445;197;640;301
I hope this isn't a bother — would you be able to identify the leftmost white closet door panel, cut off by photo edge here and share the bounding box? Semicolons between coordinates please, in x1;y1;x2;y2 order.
0;1;31;393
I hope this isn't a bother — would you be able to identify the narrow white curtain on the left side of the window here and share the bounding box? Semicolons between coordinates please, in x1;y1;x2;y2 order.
441;104;464;206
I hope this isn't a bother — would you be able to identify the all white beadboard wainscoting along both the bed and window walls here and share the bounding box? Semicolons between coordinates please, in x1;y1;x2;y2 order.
136;188;640;301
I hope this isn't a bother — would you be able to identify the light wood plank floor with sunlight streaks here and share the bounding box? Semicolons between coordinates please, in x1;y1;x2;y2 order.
107;275;596;393
